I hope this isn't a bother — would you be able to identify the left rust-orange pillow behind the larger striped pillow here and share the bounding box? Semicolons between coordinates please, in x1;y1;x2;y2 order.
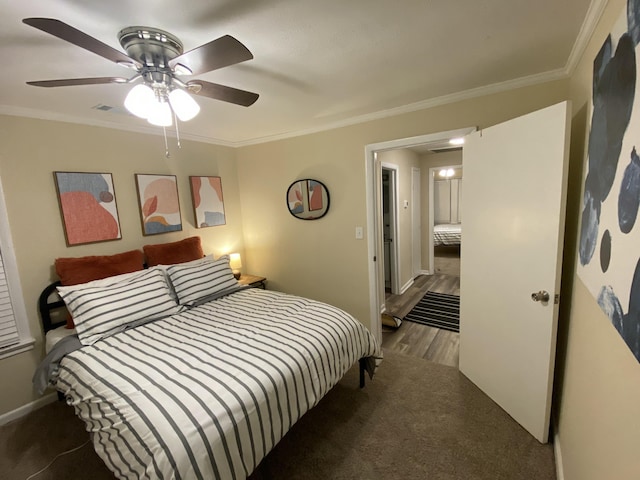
55;250;144;285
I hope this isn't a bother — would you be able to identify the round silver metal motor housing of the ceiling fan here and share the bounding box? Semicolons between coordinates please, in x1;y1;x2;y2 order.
118;26;183;68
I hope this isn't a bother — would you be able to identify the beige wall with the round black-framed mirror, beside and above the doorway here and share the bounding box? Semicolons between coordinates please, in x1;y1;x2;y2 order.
237;81;568;327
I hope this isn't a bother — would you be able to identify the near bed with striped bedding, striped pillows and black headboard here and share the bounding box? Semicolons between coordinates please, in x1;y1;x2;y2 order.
34;253;382;480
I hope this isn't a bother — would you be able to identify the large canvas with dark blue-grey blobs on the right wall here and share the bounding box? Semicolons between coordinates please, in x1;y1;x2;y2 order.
578;0;640;361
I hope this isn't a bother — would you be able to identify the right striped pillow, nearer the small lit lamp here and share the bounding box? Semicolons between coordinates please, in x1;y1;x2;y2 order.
167;256;238;306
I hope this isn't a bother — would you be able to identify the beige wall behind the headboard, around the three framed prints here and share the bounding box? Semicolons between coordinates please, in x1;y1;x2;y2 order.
0;116;245;414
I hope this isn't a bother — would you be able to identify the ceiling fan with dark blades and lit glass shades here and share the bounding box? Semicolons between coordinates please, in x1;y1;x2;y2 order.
22;18;258;127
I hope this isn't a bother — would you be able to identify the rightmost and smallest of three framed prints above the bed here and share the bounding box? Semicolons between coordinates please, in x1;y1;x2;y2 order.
189;177;227;228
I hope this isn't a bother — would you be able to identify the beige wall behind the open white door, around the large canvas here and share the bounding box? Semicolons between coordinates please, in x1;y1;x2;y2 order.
555;0;640;480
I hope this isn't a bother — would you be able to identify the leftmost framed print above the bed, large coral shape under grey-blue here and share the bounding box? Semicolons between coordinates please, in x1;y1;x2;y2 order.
53;172;122;247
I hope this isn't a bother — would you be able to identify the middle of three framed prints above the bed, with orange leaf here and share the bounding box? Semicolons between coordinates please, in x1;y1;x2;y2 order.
135;174;182;235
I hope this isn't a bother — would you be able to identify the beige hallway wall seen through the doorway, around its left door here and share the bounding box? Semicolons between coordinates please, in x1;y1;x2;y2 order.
378;149;420;293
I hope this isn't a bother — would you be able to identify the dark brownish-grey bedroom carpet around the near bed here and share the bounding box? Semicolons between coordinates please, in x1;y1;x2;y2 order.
0;352;556;480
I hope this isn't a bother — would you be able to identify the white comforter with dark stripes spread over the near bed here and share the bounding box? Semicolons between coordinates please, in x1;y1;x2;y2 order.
56;289;380;480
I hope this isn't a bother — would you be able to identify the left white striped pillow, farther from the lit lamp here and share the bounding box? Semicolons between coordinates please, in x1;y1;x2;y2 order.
58;268;181;345
